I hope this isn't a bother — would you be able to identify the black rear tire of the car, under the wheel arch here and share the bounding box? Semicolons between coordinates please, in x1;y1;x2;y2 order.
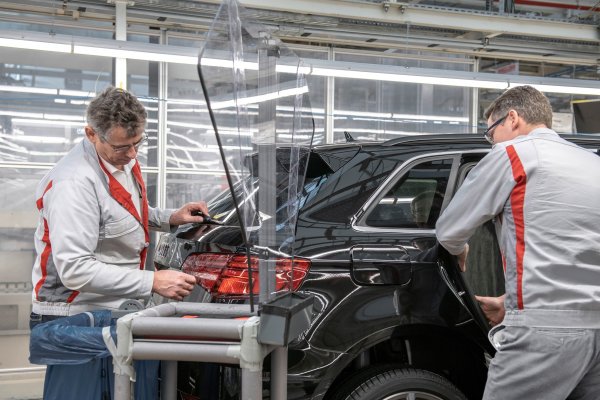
334;368;467;400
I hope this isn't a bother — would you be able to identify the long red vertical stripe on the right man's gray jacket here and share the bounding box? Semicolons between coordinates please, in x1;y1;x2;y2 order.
506;145;527;310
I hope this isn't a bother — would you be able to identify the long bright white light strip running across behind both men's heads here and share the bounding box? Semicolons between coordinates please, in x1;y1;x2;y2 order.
0;30;600;96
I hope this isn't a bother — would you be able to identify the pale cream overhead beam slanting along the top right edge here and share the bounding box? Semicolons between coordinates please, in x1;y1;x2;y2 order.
203;0;600;43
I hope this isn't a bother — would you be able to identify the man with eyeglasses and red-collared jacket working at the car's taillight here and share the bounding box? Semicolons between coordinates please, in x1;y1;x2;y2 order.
30;87;208;399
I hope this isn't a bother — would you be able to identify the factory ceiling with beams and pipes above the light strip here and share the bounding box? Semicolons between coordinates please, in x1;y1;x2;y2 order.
0;0;600;67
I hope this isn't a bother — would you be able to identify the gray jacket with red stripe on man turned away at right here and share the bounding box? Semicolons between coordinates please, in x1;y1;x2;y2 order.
436;128;600;328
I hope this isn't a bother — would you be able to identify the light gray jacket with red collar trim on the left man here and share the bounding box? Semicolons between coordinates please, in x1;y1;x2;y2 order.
32;139;173;316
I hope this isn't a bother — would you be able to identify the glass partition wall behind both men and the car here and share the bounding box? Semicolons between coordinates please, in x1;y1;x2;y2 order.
0;12;591;400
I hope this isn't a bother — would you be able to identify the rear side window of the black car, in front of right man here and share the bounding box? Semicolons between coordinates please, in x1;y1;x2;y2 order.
365;159;452;229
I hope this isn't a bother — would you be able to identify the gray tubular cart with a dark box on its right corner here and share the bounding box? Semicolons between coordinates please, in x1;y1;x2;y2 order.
113;293;312;400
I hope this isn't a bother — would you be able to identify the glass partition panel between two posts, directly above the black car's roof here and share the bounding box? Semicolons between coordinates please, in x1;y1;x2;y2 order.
333;51;475;141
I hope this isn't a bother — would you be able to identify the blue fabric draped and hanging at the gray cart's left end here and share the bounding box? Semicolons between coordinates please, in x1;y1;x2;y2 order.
29;310;160;400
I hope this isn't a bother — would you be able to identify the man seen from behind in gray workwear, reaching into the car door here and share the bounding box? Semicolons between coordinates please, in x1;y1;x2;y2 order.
436;86;600;400
